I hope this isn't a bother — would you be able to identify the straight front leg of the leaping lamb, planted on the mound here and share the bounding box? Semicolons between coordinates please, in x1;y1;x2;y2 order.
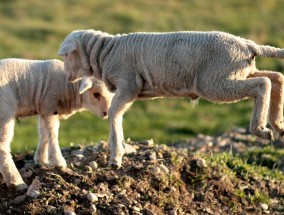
108;89;136;168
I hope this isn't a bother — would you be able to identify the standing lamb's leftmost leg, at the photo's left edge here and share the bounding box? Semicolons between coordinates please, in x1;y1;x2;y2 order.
0;119;27;190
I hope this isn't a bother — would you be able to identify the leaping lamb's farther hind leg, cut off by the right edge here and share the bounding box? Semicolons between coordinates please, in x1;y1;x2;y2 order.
250;71;284;137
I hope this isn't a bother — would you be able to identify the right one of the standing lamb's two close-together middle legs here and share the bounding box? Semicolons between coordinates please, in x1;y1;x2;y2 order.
42;115;67;168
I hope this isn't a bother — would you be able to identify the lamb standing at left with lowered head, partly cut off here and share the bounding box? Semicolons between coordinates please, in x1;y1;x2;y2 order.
0;59;112;190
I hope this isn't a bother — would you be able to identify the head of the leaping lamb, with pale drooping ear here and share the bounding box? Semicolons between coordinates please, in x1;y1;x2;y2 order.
58;30;93;82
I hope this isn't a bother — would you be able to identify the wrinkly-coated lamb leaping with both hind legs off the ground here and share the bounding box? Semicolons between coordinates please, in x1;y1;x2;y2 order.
58;30;284;167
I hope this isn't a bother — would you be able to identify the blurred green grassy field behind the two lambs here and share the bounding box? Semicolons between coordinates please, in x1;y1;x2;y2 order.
0;0;284;152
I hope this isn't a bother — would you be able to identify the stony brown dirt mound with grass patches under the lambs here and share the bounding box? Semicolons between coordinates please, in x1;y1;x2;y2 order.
0;130;284;215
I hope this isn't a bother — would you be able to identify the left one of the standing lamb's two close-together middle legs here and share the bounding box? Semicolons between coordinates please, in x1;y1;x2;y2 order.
34;116;49;164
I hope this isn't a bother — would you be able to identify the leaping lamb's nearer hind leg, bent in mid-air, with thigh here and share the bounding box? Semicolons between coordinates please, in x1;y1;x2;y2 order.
199;77;273;140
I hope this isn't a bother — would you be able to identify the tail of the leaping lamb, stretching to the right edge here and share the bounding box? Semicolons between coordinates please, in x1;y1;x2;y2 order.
246;41;284;58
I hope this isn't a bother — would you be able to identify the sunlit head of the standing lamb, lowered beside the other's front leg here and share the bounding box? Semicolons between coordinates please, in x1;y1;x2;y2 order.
79;77;114;119
